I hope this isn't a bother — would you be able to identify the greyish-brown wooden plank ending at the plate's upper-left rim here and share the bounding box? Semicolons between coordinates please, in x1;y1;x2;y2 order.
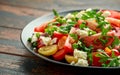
0;11;35;29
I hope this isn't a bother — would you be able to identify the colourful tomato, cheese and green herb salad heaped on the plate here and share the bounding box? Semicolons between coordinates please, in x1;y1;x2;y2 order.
28;8;120;67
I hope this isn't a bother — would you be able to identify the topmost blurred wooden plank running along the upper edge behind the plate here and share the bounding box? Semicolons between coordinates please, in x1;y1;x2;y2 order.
0;0;120;11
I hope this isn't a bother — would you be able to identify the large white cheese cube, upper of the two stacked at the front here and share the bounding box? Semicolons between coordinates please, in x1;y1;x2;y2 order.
73;49;87;59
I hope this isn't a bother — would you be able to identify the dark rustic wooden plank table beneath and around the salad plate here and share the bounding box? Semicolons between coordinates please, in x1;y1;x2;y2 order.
0;0;120;75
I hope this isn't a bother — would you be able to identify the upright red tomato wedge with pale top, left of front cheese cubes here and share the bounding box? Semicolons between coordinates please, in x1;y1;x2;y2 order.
64;36;73;53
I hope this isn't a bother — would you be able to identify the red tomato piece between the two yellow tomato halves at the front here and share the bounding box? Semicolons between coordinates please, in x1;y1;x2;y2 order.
53;49;66;61
